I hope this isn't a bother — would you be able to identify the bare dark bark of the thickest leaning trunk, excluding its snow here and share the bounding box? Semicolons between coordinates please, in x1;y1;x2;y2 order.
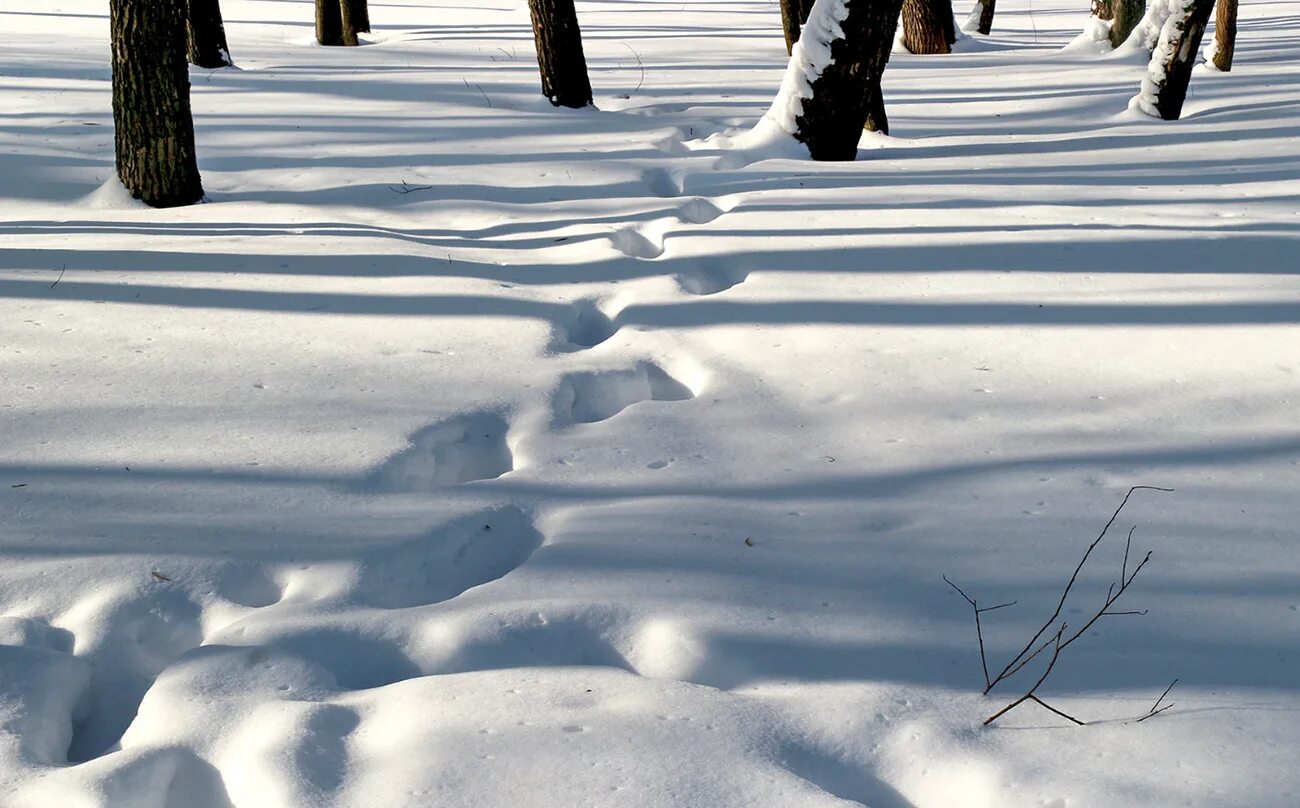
794;0;902;160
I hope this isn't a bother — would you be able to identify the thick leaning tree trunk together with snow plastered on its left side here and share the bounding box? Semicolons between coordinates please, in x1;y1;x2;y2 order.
767;0;902;160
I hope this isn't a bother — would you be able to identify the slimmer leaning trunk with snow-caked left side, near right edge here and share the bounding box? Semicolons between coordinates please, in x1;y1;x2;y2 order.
1134;0;1214;121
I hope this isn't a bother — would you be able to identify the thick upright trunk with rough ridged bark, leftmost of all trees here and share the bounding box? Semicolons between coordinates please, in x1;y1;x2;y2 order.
108;0;203;208
